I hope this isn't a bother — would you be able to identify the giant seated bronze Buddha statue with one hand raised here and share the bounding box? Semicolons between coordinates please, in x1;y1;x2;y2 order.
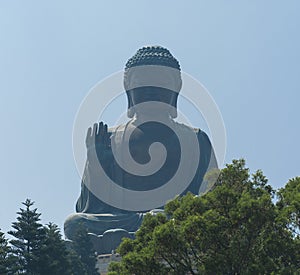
64;46;217;253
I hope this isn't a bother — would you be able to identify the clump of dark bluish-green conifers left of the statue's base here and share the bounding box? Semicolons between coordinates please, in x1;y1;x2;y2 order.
5;199;98;275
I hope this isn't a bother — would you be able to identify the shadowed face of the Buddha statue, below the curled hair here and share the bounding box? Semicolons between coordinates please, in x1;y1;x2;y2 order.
124;62;182;117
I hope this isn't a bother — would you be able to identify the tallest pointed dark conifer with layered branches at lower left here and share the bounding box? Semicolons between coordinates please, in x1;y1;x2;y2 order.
8;199;45;274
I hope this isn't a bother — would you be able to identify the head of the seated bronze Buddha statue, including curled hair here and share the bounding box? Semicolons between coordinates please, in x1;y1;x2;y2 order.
124;46;182;118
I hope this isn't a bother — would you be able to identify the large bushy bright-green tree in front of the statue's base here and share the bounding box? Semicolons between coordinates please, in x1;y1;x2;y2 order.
109;160;300;275
